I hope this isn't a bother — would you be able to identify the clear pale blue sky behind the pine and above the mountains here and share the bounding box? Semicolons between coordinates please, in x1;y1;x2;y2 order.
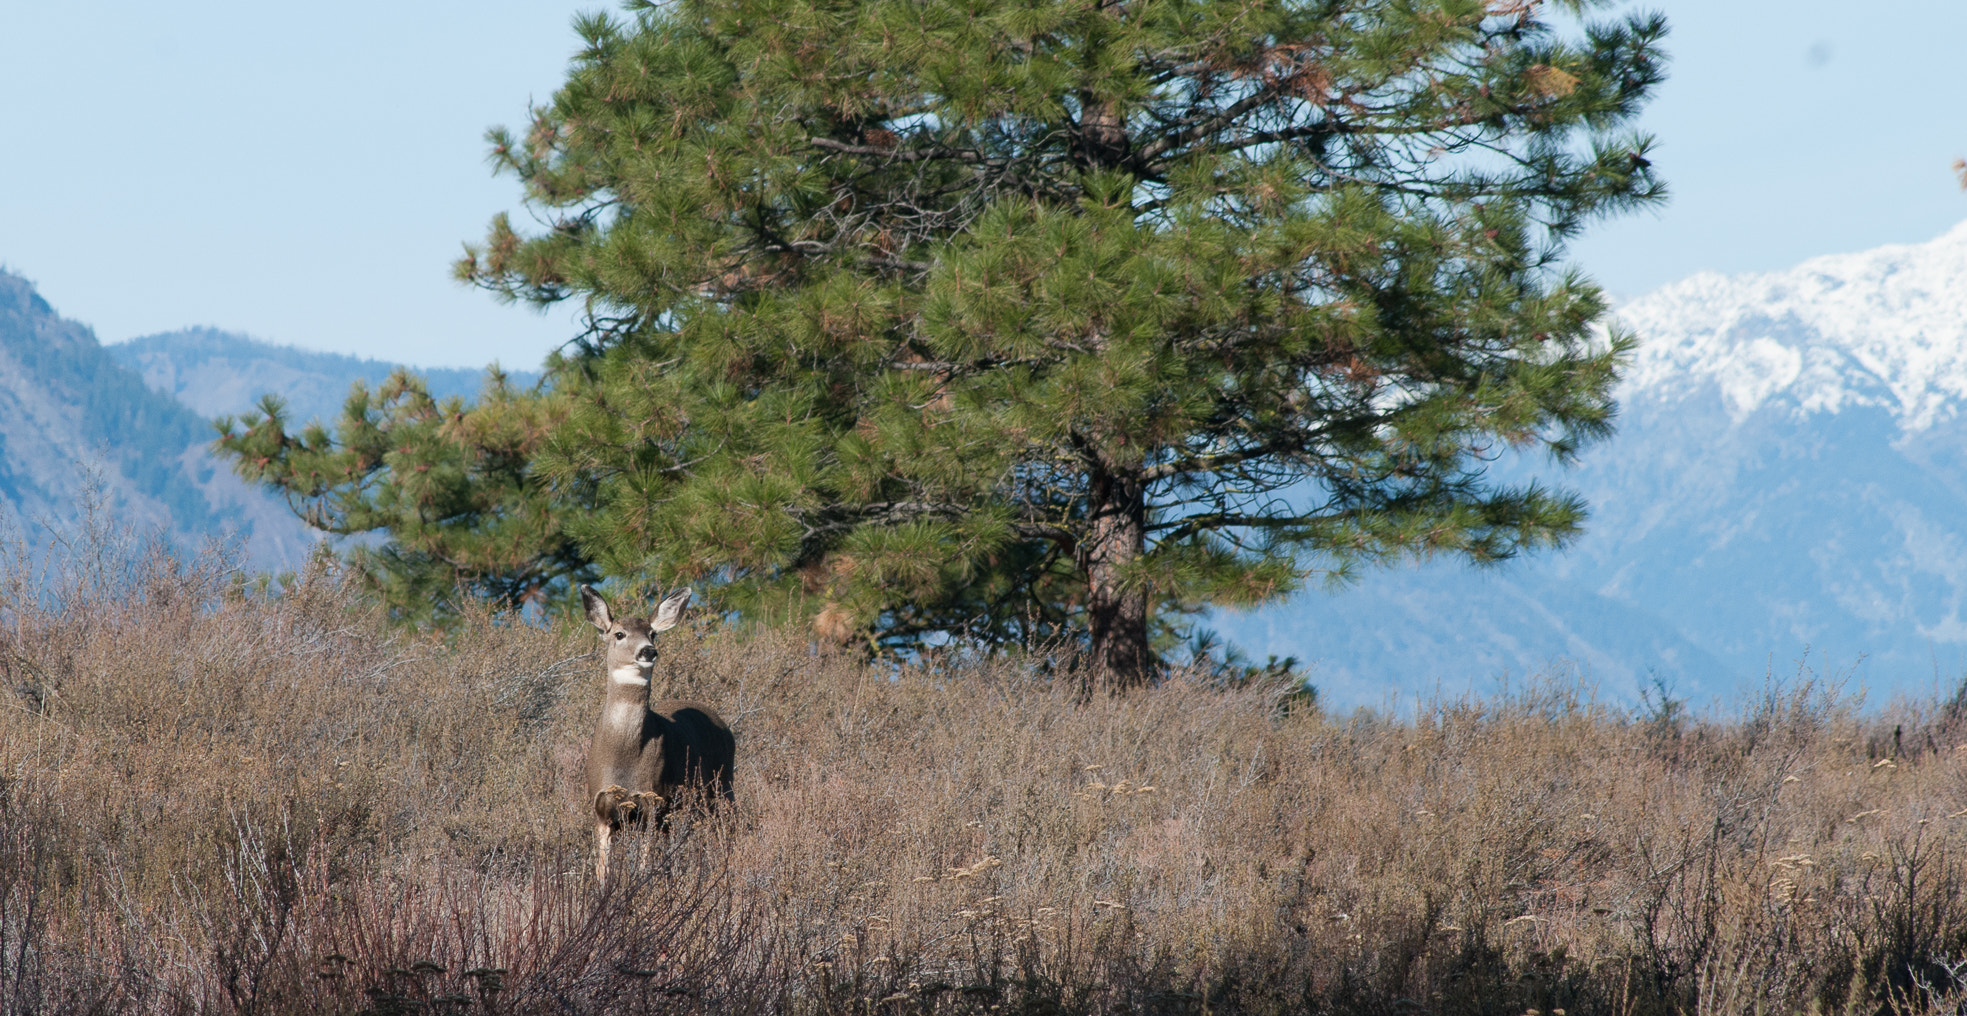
0;0;1967;367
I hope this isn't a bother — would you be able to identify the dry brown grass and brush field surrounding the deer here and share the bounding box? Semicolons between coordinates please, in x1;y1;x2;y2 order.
0;518;1967;1016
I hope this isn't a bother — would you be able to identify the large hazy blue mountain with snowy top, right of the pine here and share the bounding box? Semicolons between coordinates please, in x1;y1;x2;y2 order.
1218;224;1967;704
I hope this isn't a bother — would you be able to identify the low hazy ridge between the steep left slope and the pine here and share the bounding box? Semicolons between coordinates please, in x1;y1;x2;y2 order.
108;328;539;424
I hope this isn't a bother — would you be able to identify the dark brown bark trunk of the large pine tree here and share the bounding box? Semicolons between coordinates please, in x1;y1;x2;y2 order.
1078;461;1153;688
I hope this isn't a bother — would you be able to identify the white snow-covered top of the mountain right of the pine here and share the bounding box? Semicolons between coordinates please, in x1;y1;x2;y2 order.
1617;222;1967;432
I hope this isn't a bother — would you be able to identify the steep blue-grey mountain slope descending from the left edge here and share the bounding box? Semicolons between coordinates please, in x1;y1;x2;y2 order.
0;271;311;566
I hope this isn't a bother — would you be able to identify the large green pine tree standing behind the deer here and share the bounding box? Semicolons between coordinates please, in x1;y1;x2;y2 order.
220;0;1664;686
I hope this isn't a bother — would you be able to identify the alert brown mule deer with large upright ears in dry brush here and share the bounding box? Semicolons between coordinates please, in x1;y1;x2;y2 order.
580;586;738;882
